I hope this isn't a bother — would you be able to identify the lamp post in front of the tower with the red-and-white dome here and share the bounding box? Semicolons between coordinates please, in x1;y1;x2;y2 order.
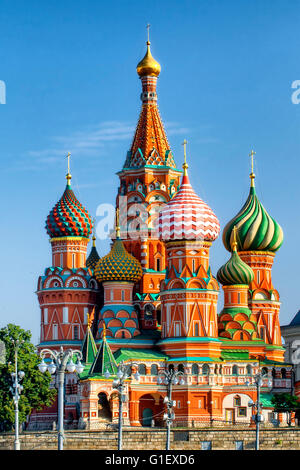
157;369;184;450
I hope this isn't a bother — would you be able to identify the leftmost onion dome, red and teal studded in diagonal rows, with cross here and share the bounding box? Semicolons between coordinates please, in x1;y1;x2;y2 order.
45;160;93;238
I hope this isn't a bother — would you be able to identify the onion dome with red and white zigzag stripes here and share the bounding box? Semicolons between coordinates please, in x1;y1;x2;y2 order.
158;175;220;241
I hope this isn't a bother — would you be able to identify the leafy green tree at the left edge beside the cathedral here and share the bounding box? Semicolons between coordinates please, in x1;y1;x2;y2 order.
0;323;57;431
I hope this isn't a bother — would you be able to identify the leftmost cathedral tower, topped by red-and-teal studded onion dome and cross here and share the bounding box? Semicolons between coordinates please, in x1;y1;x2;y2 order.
37;154;98;349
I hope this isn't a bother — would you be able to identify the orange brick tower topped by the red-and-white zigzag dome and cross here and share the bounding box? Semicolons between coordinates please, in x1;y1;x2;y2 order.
159;142;220;357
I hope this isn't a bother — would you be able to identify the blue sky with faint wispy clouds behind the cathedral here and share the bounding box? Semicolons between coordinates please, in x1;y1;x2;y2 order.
0;0;300;341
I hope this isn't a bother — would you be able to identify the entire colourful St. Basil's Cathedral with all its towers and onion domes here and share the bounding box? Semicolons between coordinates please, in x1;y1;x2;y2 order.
30;40;292;429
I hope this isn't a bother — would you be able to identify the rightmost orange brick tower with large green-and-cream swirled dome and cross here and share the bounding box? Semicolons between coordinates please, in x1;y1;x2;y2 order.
223;151;284;361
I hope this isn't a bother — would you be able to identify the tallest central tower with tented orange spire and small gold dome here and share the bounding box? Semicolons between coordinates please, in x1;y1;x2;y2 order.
117;34;181;329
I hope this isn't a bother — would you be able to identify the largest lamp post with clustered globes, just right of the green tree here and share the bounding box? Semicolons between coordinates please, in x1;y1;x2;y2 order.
39;347;84;450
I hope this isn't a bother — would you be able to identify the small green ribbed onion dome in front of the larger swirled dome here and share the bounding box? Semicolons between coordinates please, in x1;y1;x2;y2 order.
217;227;254;286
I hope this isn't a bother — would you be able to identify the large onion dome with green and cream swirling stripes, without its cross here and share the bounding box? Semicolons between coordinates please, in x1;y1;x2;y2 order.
223;185;283;252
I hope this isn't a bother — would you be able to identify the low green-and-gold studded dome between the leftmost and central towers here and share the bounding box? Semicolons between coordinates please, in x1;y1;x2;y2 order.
94;238;143;282
